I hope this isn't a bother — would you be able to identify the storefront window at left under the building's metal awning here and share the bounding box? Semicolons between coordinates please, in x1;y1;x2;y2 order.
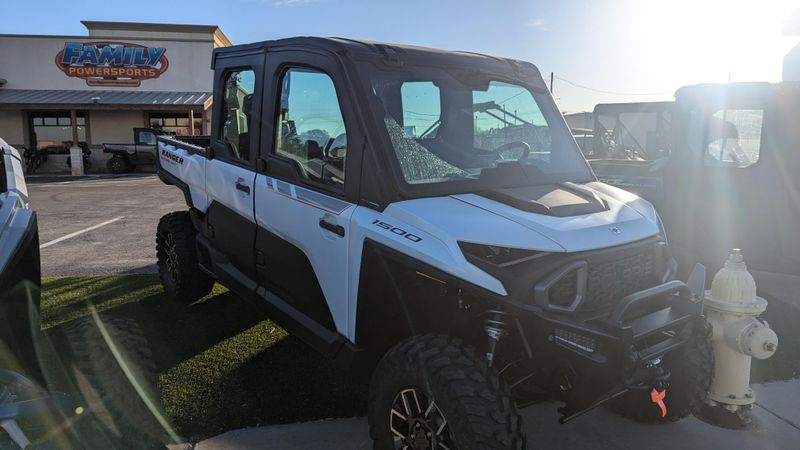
30;111;87;154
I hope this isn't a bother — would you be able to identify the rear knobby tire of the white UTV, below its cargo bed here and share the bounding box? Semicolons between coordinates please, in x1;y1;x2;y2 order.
156;211;214;303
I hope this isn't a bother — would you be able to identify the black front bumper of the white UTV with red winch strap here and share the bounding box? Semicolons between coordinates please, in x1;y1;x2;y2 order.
511;264;705;423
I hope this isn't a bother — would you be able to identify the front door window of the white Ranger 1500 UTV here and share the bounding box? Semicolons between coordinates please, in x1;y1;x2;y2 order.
275;69;347;187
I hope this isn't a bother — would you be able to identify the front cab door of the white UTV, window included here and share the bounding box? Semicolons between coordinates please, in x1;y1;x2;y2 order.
255;51;363;334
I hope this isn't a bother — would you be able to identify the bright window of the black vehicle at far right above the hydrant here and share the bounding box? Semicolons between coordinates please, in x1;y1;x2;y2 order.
705;109;764;168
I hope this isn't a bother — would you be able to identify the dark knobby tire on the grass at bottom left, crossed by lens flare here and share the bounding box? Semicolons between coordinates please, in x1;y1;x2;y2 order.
63;315;167;449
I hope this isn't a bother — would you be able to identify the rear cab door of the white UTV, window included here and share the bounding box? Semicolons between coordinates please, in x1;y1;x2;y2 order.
203;52;264;291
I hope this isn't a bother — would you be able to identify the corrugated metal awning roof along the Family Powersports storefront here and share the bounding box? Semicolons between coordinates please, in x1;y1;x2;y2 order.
0;89;211;106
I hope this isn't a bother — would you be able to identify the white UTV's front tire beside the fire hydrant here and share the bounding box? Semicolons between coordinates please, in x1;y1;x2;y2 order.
608;321;714;423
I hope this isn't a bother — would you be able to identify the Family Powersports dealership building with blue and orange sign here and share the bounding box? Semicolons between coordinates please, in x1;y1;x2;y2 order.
0;21;231;173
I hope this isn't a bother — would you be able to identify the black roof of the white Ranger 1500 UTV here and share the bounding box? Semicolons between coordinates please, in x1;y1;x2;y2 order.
212;37;539;73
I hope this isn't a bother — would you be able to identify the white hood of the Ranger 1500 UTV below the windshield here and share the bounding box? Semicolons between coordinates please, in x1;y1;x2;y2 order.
385;182;659;252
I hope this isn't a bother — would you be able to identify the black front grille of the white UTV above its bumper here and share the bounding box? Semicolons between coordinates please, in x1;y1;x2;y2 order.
535;247;659;313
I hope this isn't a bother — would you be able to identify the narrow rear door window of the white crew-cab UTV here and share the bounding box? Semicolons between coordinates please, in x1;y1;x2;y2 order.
220;70;256;161
